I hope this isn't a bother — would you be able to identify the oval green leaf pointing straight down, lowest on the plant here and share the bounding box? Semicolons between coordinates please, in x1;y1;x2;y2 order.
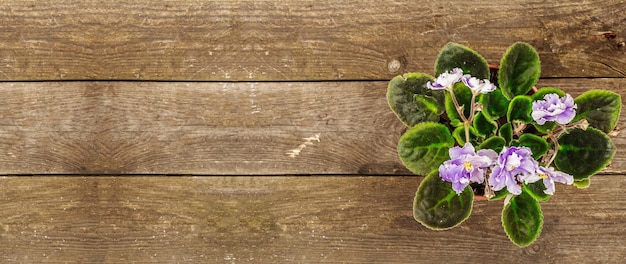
502;191;543;247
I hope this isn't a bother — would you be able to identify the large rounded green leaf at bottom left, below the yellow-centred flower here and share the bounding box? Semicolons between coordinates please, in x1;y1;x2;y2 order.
413;170;474;230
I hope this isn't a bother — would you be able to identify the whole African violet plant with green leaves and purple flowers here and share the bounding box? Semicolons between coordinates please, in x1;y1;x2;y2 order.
387;42;622;247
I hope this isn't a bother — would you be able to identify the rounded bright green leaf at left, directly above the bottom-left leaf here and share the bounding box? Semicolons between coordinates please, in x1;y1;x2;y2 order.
398;122;454;175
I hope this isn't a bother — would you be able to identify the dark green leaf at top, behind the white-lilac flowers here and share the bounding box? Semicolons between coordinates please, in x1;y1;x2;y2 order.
435;42;491;79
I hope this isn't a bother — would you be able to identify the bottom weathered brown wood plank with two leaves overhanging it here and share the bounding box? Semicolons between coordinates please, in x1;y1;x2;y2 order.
0;175;626;263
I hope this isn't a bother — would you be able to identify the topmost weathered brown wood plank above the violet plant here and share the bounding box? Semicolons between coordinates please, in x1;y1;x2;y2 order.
0;0;626;81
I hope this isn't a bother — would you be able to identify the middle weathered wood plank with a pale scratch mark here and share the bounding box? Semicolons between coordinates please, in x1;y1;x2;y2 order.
0;79;626;175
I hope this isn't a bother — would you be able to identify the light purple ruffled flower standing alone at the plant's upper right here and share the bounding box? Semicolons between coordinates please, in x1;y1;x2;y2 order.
531;93;576;125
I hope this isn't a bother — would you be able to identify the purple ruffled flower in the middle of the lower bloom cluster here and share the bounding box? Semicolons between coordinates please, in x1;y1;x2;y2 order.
489;147;538;195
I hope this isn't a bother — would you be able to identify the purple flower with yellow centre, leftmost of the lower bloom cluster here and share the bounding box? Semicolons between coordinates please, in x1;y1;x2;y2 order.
439;143;498;194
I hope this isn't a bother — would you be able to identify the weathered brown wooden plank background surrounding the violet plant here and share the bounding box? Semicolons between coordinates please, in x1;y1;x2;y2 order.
0;0;626;263
